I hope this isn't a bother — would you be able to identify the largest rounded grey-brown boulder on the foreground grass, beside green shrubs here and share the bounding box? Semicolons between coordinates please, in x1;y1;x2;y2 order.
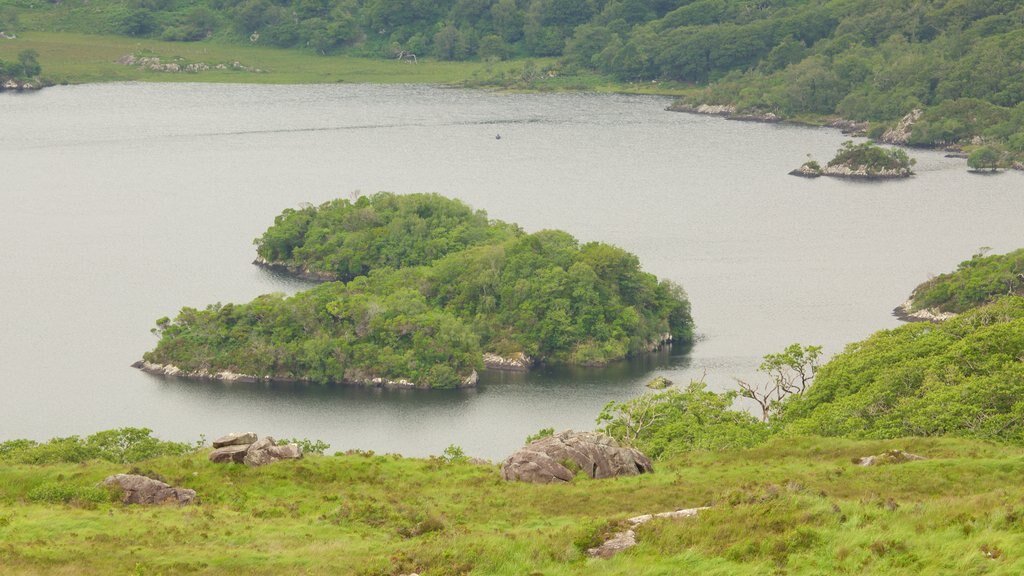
502;430;654;484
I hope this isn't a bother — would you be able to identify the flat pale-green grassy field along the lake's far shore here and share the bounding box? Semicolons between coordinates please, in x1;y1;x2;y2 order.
0;32;684;94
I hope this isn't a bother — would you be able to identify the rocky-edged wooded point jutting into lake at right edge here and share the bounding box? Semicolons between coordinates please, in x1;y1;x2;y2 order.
903;248;1024;316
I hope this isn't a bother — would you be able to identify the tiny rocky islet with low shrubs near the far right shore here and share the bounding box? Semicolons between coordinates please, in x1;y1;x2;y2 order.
790;140;916;179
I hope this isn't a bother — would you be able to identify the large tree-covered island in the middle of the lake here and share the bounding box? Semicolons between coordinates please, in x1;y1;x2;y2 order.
139;194;693;387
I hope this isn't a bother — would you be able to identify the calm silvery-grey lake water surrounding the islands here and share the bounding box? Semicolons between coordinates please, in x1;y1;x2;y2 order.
0;84;1024;458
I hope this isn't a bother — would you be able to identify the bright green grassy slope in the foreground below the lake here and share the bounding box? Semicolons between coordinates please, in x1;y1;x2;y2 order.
0;439;1024;575
